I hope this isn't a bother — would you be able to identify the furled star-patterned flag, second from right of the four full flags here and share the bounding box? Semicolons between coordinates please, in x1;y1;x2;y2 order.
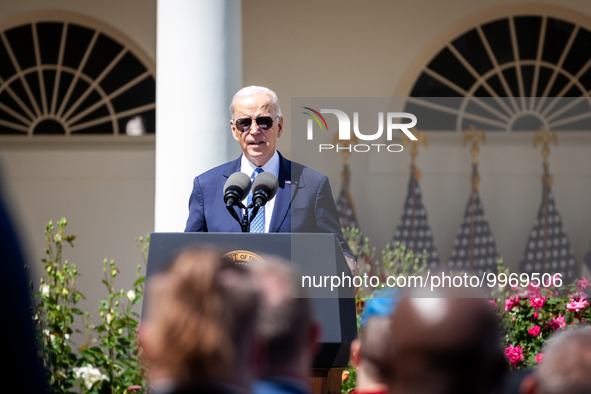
448;189;500;275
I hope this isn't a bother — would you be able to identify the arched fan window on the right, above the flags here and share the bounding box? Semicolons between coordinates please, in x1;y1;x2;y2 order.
407;8;591;132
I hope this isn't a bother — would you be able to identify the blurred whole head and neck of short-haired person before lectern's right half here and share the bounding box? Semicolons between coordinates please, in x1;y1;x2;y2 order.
248;256;319;393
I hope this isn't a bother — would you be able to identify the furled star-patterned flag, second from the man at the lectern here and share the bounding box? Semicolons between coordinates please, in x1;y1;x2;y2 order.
392;166;440;268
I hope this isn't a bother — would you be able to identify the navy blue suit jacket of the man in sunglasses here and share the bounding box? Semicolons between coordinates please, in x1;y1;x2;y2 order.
185;153;351;256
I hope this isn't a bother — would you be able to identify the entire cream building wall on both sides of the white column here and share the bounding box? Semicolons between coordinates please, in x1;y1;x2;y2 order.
0;0;591;326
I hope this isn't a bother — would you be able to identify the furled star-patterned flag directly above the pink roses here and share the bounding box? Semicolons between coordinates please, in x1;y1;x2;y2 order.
520;182;577;283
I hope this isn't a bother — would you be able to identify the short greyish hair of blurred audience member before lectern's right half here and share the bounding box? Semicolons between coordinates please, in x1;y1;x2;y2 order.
248;256;314;368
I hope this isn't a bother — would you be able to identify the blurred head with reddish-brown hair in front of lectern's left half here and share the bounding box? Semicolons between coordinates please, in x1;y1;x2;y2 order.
140;250;260;392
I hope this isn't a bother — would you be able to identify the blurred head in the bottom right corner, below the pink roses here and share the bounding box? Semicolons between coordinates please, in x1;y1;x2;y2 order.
521;326;591;394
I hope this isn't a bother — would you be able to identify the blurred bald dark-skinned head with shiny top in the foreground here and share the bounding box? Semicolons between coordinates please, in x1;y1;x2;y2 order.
391;290;508;394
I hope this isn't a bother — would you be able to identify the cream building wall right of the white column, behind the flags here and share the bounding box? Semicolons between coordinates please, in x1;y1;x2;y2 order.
243;0;591;274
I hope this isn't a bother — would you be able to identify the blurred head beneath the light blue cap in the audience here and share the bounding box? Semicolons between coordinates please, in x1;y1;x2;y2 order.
351;316;393;392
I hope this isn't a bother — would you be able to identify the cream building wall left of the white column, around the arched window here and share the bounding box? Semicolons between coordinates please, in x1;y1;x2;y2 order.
0;0;156;332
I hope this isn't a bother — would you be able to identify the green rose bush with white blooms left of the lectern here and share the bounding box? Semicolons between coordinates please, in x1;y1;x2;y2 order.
33;218;149;394
